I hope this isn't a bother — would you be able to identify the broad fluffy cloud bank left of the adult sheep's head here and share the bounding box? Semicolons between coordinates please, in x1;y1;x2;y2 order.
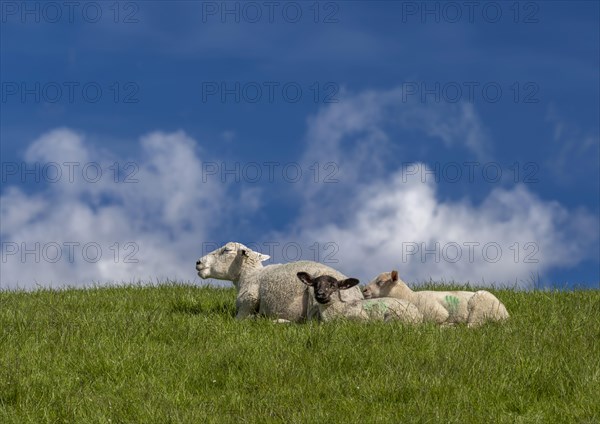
0;129;227;288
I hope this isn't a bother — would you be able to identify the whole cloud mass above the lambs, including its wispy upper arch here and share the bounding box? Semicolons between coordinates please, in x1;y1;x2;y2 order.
273;90;598;286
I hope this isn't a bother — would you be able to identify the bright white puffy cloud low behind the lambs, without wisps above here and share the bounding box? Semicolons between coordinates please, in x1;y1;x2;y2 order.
287;171;598;286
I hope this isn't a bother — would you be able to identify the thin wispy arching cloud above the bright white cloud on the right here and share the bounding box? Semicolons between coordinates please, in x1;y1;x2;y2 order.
300;88;491;225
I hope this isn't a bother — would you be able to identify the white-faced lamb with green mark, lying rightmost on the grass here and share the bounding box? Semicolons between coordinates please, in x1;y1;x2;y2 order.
363;271;508;327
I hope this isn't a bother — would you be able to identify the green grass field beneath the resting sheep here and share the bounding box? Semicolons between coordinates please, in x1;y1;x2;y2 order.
0;284;600;424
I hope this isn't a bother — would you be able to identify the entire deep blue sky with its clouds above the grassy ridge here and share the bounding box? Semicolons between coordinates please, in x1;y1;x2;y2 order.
0;1;600;288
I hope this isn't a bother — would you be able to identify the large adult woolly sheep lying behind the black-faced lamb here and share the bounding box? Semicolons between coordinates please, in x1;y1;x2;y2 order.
196;242;363;322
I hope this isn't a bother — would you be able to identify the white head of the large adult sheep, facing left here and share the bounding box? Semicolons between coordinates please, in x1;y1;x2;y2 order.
196;242;270;282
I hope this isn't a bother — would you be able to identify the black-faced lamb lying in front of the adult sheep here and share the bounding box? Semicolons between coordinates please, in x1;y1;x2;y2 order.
297;272;423;324
